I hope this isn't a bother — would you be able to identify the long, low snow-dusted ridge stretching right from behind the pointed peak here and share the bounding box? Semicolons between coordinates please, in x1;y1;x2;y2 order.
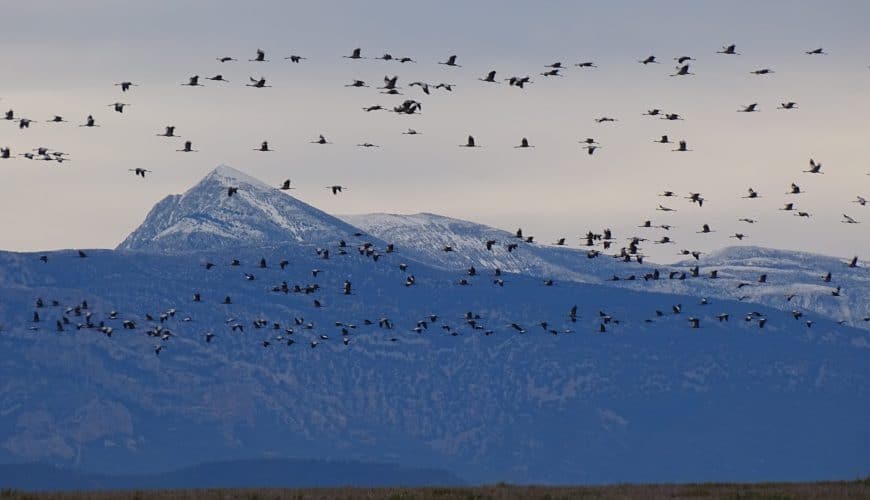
342;213;870;329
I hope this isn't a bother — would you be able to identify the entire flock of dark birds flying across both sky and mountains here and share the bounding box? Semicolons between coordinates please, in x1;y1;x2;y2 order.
0;44;870;348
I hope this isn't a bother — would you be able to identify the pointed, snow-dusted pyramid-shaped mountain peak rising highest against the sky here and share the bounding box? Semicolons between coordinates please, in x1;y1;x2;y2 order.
118;165;366;253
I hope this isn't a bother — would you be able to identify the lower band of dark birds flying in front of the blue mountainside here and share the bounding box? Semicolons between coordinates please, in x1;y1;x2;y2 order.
15;230;870;356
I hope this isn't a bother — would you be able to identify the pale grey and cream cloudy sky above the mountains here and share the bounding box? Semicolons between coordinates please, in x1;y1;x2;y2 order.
0;0;870;262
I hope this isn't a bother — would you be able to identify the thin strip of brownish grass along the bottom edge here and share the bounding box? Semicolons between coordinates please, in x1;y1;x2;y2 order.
0;479;870;500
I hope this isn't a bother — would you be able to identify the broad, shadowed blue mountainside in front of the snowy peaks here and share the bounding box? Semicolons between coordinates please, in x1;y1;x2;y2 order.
0;169;870;483
